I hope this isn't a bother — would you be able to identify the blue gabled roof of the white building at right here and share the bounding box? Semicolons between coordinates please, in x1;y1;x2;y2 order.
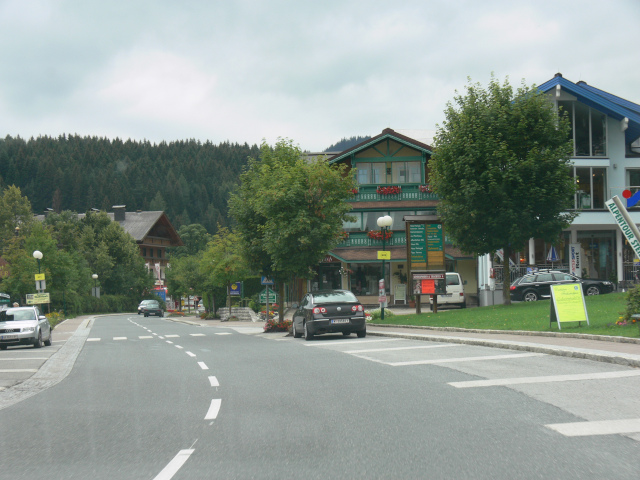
538;73;640;143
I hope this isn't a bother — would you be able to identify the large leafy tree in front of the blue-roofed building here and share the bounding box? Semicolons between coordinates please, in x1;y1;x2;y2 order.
429;77;575;304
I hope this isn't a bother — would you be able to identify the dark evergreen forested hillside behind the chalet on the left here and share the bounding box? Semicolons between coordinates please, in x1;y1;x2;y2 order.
0;135;259;233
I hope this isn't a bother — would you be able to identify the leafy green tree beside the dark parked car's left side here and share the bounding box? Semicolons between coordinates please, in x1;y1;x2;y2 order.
229;139;355;318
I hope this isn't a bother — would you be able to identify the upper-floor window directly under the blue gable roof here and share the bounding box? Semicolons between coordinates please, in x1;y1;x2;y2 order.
558;101;607;157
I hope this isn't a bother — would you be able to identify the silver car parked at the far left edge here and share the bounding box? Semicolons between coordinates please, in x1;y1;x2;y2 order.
0;307;52;350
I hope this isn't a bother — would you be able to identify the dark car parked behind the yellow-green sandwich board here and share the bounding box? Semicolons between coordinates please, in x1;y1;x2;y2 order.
510;270;613;302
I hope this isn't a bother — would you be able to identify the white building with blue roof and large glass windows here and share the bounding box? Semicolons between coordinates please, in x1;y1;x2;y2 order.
478;73;640;304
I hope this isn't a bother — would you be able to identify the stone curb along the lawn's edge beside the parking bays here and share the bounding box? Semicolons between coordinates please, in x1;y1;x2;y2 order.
367;325;640;368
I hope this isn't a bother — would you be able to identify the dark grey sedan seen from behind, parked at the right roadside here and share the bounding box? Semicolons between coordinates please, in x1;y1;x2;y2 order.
292;290;367;340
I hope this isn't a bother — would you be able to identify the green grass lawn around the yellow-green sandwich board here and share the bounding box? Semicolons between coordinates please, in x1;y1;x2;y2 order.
371;292;640;338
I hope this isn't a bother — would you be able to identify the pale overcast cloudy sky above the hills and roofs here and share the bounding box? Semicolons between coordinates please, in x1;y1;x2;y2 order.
0;0;640;151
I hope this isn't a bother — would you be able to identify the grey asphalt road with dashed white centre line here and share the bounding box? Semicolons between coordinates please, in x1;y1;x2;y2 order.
0;315;640;479
